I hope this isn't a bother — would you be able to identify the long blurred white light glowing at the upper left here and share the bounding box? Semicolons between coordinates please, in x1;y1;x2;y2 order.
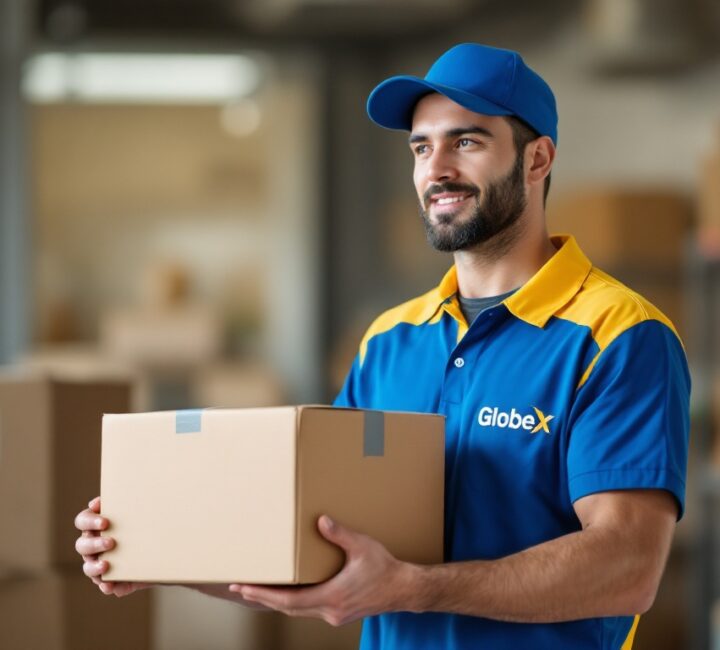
23;53;260;104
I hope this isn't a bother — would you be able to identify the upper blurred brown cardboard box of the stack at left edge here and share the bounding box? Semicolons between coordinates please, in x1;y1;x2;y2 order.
0;373;130;570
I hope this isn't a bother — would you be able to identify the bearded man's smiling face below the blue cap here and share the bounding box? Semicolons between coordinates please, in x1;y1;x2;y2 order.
410;94;526;252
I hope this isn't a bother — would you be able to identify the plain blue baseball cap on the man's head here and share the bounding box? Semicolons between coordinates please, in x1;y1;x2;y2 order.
367;43;557;144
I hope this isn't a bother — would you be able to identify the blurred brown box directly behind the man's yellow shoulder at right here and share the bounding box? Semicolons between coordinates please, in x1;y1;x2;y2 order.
548;188;693;335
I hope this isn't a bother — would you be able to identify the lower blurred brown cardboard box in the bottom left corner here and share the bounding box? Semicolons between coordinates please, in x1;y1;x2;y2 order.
0;566;151;650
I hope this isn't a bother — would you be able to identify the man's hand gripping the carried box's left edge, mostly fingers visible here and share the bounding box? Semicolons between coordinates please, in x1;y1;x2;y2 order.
75;497;150;597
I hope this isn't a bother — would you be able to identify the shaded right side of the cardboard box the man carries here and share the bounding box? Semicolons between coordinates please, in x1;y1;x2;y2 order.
298;410;445;582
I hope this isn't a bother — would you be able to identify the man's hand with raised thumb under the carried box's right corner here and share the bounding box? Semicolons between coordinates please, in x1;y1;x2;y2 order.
230;515;417;626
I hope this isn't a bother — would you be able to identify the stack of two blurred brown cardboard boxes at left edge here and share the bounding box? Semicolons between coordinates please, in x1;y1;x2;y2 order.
0;373;150;650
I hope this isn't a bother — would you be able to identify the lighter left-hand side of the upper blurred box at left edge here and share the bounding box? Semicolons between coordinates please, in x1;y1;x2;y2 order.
0;379;51;570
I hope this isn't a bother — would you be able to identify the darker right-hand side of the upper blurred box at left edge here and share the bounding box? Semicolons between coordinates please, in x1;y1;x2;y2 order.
51;382;130;566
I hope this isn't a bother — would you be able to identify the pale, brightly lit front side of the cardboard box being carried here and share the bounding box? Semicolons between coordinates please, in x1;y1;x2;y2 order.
102;408;295;583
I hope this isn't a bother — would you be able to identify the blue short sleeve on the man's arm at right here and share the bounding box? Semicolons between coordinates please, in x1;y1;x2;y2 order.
567;320;690;519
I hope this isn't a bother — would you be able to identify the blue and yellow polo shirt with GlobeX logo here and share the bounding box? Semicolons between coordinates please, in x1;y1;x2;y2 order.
335;236;690;650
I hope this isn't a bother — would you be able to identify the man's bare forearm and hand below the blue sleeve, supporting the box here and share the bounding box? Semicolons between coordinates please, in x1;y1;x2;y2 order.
231;490;677;625
